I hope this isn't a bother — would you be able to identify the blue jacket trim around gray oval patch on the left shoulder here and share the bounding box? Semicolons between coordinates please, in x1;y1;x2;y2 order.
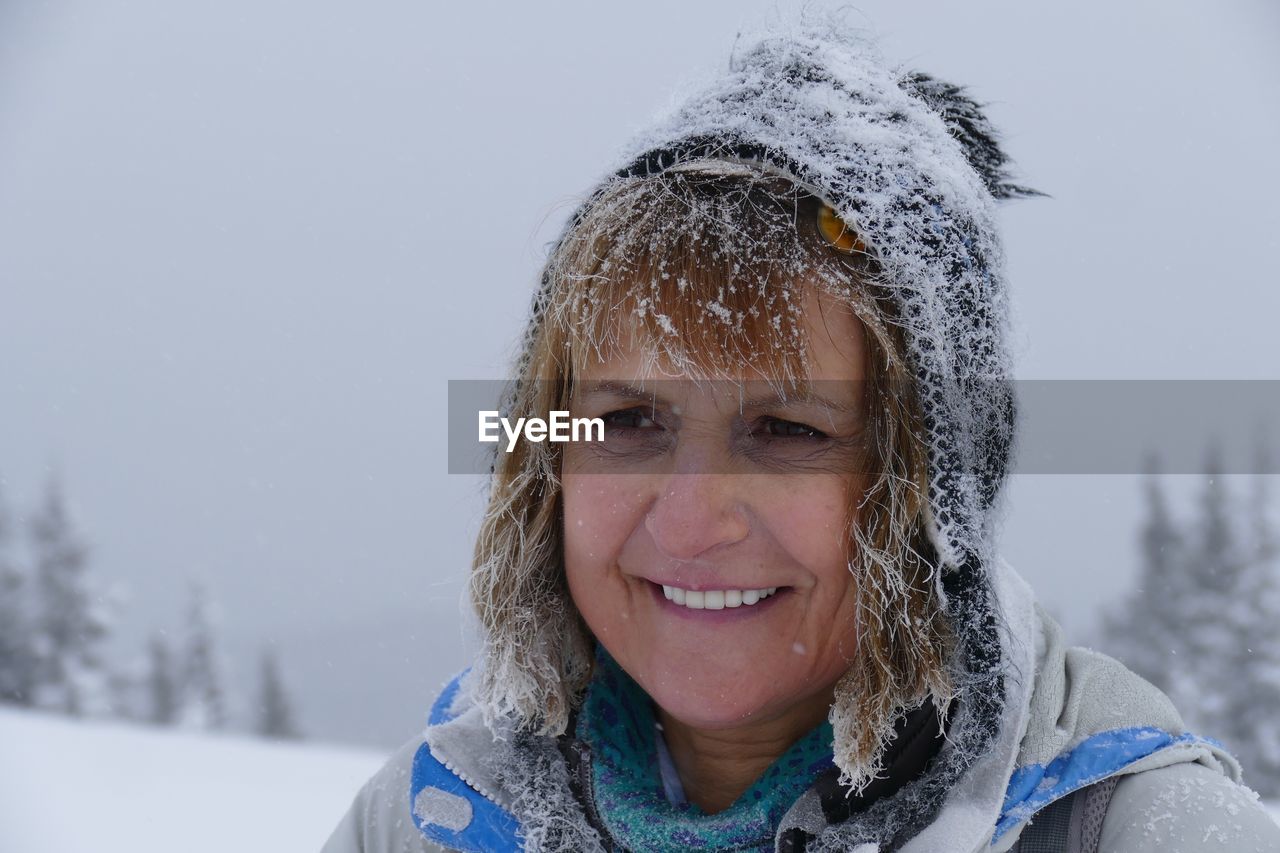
408;671;522;853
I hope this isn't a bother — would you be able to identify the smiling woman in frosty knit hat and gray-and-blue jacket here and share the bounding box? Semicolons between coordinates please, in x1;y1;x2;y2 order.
326;14;1280;853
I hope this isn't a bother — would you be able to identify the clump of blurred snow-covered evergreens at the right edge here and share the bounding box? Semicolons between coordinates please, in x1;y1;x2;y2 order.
1103;443;1280;797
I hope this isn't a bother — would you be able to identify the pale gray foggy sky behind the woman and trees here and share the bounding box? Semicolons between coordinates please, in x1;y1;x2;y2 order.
0;0;1280;747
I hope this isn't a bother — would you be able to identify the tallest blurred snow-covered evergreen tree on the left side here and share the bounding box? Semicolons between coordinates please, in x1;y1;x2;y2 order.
31;480;110;716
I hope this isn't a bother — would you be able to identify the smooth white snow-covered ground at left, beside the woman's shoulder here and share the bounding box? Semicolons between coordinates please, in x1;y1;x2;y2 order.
0;708;385;853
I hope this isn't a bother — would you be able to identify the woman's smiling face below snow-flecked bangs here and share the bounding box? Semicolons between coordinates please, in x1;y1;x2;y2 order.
562;288;865;729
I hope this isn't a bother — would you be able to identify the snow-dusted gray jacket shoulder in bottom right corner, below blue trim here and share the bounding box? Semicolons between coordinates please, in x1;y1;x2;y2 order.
1098;763;1280;853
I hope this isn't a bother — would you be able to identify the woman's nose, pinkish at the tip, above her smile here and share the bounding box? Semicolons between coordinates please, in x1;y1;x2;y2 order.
645;474;750;561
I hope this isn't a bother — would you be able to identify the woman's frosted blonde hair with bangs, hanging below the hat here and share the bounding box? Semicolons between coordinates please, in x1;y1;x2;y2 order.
470;168;954;789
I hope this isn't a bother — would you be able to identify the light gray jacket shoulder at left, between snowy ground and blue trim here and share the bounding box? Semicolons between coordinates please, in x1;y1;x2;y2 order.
320;736;447;853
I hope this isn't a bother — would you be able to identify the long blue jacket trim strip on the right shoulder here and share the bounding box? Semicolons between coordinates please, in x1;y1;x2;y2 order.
992;726;1216;840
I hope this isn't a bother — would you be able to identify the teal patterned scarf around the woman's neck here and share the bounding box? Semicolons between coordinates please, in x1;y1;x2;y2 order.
576;648;832;850
